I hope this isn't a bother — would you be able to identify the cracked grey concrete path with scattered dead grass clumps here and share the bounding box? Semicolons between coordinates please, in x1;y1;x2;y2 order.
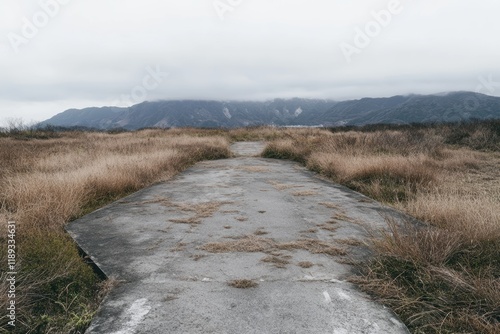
67;143;407;334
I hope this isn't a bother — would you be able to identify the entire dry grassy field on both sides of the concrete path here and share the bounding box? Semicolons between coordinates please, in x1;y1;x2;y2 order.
0;122;500;333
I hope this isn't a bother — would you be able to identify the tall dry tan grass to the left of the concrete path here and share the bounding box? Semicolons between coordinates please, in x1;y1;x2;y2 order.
0;130;230;333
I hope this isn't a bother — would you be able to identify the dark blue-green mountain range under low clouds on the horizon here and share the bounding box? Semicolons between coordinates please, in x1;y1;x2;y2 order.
41;92;500;130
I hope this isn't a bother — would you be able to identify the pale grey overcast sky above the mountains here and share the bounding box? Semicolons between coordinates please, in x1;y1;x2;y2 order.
0;0;500;125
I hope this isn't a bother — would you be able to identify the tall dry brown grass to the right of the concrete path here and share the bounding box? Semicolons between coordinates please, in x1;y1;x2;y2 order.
263;122;500;333
